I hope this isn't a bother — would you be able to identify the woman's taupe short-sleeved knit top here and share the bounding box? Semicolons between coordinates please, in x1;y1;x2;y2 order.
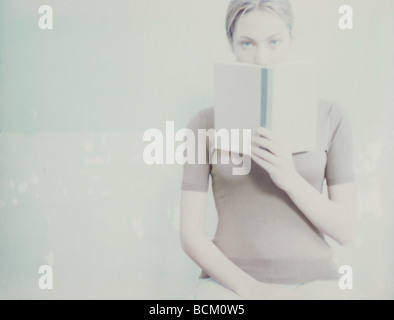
182;100;354;284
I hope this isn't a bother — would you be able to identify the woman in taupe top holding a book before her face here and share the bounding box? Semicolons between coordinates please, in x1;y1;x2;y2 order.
181;0;356;299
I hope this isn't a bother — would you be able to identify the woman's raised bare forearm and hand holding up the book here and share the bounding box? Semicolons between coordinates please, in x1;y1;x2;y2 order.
252;128;356;245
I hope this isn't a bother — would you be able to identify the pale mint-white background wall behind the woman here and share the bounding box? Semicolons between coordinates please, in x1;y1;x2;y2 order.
0;0;394;299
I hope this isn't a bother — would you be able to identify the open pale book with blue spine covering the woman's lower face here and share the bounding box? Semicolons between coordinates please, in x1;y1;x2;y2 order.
214;62;317;153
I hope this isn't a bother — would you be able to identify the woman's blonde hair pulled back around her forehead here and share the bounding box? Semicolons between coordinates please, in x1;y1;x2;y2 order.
226;0;294;42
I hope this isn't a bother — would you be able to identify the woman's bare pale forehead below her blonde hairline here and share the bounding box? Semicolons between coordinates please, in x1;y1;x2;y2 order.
234;9;289;40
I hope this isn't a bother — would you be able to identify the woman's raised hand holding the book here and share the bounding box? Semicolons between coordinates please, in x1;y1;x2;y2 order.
251;128;301;191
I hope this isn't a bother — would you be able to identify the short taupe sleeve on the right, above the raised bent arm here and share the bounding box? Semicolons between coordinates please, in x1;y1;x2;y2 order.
325;104;354;186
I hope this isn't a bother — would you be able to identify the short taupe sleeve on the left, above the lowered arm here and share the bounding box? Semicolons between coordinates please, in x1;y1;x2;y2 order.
181;108;213;192
